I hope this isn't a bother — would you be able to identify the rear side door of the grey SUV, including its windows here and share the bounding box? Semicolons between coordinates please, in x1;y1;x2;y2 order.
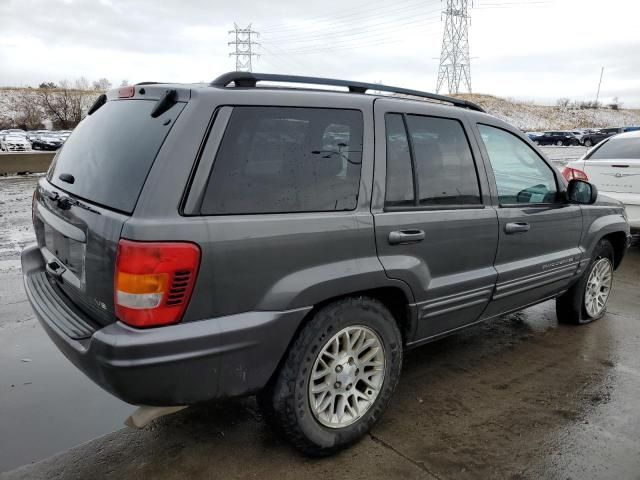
372;99;498;341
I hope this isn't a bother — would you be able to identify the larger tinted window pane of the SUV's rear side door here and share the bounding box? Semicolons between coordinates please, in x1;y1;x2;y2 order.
407;115;482;206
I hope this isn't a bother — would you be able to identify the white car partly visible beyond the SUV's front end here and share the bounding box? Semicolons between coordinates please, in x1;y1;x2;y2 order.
562;131;640;234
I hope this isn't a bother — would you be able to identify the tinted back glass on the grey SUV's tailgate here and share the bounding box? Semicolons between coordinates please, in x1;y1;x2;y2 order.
48;100;185;213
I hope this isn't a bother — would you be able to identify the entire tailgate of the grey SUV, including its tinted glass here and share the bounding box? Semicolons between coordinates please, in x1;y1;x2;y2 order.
33;89;186;324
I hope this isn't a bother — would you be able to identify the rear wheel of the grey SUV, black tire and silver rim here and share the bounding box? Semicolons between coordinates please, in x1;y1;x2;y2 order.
258;297;402;456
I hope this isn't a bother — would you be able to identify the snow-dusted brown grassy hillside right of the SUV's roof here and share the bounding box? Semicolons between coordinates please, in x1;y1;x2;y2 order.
458;94;640;131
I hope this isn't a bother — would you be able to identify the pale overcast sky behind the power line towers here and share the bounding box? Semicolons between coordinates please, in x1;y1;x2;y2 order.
0;0;640;108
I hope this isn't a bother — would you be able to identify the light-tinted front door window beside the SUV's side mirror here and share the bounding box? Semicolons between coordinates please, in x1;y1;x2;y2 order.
478;124;558;204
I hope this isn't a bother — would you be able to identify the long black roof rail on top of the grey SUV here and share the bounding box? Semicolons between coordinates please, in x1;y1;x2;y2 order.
209;72;484;112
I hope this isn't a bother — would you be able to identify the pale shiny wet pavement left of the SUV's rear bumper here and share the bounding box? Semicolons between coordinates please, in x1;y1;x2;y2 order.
0;176;133;472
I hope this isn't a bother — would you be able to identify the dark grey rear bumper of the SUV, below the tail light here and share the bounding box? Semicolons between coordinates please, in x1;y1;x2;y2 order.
22;246;310;406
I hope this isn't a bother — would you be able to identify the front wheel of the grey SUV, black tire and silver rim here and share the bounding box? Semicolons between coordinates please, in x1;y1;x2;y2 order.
556;240;614;325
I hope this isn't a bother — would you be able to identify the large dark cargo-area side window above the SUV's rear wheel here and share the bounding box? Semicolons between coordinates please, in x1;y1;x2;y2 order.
201;106;363;215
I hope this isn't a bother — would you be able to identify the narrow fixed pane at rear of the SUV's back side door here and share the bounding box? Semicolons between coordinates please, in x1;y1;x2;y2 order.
384;113;415;206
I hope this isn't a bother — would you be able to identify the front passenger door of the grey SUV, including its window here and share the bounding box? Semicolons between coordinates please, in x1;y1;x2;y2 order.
477;123;582;317
